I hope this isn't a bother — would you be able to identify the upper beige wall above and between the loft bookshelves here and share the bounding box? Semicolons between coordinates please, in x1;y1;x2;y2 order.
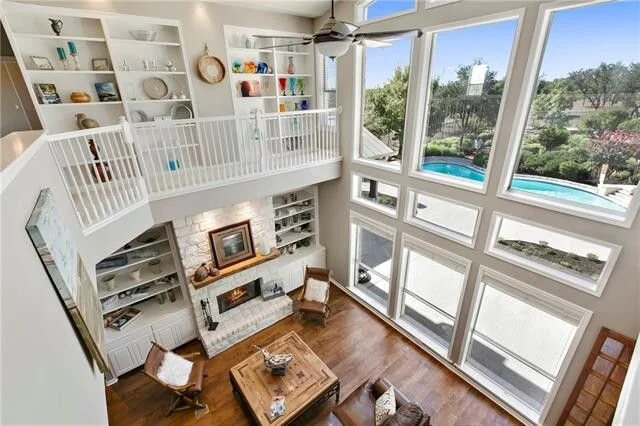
25;0;312;117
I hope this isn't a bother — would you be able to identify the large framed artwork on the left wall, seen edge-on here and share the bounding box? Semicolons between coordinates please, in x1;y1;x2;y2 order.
26;188;108;373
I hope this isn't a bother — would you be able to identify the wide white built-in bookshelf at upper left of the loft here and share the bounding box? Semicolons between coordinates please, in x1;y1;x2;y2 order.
3;2;197;133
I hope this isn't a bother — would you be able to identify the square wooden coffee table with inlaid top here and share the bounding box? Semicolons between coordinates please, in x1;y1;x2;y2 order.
229;331;340;425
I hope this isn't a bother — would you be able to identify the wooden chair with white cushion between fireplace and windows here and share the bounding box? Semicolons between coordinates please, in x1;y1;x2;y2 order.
293;266;331;327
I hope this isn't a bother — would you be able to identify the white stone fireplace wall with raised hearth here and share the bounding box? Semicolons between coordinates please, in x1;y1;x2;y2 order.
173;197;292;357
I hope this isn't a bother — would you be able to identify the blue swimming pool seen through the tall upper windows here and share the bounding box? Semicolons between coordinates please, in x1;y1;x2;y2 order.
422;163;625;211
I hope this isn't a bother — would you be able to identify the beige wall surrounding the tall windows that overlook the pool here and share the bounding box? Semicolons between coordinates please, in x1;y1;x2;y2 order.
314;0;640;425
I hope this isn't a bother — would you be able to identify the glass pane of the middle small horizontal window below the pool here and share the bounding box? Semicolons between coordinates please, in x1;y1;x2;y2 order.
411;192;479;244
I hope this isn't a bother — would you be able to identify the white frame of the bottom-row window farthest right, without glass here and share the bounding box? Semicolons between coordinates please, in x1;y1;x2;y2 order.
456;265;593;424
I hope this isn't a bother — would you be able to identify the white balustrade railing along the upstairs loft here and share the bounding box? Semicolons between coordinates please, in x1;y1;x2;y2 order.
48;108;340;232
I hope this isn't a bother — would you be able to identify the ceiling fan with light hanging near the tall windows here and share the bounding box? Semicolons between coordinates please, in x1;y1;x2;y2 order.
254;0;422;59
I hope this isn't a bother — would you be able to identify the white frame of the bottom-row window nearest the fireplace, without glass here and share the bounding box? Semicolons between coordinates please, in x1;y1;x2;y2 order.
349;210;396;316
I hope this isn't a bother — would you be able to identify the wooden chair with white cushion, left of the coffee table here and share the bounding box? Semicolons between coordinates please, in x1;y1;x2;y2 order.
144;342;208;416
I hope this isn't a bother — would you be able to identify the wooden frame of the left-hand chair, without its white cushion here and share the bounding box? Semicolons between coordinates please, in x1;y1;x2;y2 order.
144;342;207;416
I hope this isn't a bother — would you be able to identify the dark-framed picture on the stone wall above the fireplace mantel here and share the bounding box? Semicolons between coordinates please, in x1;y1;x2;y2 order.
209;220;256;269
